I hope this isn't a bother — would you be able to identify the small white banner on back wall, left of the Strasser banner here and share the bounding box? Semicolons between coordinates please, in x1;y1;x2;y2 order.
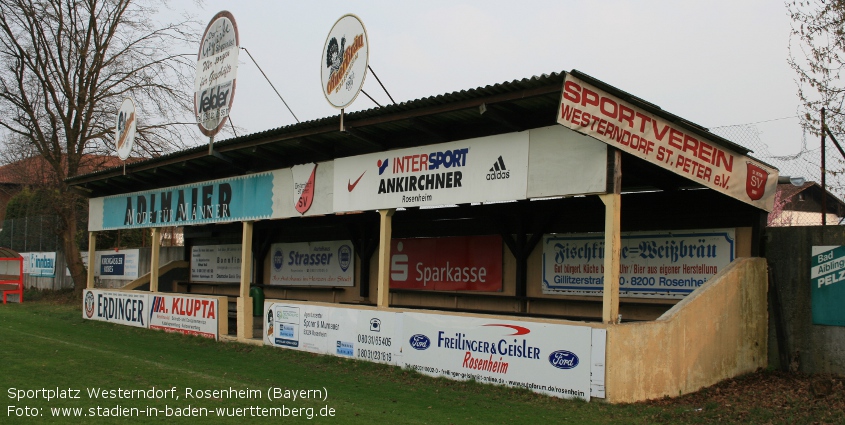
191;244;242;282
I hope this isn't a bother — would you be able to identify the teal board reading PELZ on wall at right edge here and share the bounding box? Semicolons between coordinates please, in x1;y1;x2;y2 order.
810;246;845;326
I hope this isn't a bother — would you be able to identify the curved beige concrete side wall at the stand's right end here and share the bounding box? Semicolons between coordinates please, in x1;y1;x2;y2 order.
605;258;767;403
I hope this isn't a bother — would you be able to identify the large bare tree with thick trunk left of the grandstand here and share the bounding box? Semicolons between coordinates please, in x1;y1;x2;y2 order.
0;0;198;291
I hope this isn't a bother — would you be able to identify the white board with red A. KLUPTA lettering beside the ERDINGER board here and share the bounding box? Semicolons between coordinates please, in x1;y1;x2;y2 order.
149;294;221;339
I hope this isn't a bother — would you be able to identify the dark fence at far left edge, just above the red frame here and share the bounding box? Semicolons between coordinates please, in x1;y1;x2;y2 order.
0;215;62;252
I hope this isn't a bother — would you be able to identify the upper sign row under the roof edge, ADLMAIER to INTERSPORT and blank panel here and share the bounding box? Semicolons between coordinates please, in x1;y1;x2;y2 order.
88;125;607;231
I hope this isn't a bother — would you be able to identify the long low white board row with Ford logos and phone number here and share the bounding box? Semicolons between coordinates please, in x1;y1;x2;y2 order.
264;301;606;400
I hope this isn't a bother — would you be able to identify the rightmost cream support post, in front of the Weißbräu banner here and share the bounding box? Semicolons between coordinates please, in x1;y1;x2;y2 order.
599;193;622;323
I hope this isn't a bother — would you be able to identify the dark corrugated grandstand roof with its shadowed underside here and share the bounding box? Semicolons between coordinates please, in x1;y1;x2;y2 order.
67;71;760;197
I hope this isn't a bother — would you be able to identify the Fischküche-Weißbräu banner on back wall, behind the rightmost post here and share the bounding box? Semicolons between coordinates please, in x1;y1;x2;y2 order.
542;229;736;298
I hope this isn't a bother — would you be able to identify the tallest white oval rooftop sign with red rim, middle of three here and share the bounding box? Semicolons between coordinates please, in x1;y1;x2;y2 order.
194;10;240;137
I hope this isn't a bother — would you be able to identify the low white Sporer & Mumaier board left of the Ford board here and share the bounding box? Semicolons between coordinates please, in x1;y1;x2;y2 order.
264;301;402;365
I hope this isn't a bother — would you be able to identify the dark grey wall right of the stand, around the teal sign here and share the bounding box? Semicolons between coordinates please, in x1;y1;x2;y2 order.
766;226;845;374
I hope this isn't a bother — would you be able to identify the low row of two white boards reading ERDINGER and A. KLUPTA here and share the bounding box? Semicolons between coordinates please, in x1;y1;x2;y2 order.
82;289;221;339
